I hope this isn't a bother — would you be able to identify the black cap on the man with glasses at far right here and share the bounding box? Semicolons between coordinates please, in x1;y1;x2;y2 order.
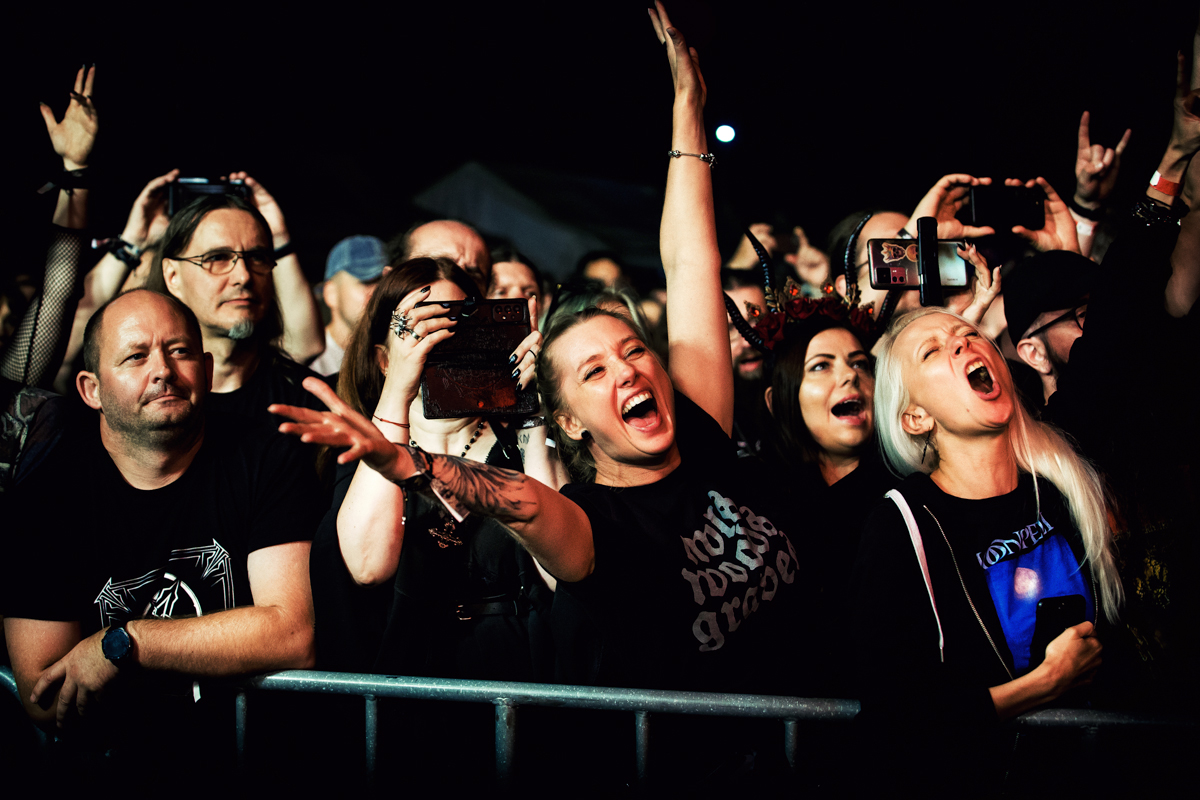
1001;249;1097;347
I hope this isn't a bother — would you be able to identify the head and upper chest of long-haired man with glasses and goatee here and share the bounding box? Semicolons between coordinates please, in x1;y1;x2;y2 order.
146;194;333;425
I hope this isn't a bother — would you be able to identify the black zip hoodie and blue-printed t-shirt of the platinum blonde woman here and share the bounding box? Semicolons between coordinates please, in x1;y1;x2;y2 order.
852;473;1096;791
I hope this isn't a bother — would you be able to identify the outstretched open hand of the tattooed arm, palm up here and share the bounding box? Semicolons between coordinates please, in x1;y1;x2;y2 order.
266;378;400;480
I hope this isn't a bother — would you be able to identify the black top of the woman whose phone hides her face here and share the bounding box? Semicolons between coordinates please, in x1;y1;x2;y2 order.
310;428;553;681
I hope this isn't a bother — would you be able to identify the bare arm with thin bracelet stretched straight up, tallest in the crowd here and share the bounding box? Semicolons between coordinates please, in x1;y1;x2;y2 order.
649;2;733;433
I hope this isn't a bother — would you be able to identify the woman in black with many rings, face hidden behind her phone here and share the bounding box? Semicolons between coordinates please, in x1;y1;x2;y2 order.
310;258;554;680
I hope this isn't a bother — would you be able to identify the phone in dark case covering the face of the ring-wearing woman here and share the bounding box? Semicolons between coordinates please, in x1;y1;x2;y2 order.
418;299;539;420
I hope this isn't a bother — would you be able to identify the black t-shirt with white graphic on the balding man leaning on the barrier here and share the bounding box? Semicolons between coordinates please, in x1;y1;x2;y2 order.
0;414;324;637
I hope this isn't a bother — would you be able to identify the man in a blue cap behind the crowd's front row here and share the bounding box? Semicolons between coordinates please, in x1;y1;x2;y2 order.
308;236;388;375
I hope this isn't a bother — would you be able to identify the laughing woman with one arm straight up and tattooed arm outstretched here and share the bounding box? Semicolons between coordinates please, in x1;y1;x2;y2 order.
274;6;799;693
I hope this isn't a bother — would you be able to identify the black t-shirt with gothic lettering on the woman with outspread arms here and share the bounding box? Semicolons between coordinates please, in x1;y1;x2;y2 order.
556;392;798;692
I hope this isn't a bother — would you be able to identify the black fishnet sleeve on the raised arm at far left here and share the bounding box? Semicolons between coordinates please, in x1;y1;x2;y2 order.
0;225;85;389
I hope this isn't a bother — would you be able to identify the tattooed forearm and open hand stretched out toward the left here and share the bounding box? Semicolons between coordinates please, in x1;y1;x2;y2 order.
270;378;595;582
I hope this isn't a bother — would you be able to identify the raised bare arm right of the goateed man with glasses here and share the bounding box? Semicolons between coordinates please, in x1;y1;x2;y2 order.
229;173;325;363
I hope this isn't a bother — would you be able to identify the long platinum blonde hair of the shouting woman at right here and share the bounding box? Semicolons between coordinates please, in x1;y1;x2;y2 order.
875;308;1124;621
